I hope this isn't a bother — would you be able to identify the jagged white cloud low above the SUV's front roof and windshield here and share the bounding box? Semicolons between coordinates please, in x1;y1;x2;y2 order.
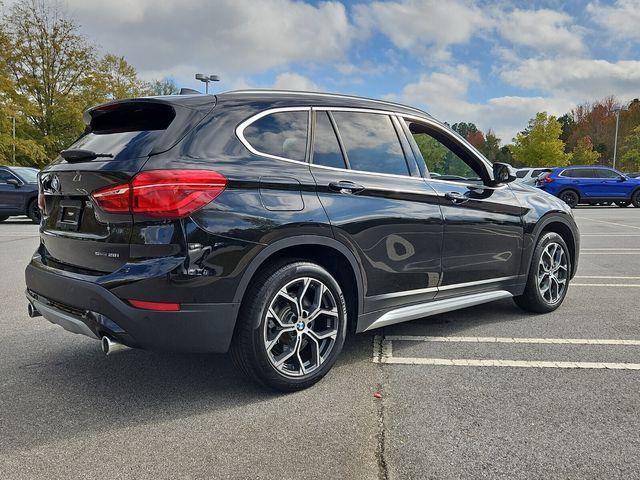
388;66;574;143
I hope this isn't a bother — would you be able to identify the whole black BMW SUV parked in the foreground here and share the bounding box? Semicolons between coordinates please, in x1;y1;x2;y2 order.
26;91;579;390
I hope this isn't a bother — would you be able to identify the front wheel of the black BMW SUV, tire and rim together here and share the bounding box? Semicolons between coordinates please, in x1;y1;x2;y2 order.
514;232;571;313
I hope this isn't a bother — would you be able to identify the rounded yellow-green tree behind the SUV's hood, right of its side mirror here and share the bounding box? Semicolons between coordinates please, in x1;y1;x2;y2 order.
510;112;571;167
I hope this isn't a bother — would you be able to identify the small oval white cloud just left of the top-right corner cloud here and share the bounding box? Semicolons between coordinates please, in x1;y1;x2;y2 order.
498;9;584;53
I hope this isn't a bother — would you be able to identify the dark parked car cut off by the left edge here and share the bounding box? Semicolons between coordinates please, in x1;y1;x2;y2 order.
0;166;40;223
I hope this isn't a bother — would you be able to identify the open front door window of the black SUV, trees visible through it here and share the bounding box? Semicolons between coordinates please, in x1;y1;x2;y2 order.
407;121;484;183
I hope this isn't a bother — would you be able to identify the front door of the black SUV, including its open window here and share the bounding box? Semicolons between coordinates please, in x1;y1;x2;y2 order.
407;121;523;298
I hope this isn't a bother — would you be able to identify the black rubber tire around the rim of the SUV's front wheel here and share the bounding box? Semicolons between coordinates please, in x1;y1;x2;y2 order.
513;232;571;313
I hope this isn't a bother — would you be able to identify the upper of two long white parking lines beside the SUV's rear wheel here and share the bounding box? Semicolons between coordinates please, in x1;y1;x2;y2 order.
384;335;640;347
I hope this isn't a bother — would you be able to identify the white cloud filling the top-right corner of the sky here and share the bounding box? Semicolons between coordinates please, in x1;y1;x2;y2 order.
587;0;640;40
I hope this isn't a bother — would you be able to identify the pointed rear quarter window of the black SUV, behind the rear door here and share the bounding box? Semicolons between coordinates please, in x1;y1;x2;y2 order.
243;111;309;161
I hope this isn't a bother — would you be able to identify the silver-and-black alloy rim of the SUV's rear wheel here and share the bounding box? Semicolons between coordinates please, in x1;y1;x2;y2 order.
263;277;340;377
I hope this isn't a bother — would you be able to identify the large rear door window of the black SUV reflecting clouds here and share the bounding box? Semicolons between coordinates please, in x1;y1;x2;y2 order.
333;112;409;176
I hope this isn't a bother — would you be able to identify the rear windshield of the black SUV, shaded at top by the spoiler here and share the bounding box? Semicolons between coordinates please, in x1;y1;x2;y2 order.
69;103;175;161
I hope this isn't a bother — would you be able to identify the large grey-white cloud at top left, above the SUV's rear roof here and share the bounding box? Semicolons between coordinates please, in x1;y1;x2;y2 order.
66;0;352;81
